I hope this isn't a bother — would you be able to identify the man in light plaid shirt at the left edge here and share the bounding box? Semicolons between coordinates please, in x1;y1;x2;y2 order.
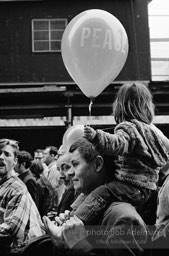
0;139;44;256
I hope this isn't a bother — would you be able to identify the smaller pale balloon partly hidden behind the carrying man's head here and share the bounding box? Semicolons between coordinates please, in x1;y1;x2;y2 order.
62;124;84;147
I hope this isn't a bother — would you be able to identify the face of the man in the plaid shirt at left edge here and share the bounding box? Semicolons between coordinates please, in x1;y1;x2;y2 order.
0;145;17;179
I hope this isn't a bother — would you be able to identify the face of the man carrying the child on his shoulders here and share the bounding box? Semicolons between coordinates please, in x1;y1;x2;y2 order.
69;150;97;195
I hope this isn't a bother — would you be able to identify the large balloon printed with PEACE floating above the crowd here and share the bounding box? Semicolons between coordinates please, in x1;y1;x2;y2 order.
61;9;128;98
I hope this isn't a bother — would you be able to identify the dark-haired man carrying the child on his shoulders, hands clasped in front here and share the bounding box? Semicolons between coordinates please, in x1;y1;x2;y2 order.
42;138;148;255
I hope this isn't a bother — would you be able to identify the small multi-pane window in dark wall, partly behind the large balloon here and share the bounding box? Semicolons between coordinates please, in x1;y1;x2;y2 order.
32;19;67;52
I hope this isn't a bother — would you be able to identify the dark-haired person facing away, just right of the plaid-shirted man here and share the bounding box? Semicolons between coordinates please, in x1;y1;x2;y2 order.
30;160;55;217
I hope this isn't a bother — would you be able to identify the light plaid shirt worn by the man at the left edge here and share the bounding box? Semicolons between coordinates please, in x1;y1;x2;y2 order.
0;175;43;247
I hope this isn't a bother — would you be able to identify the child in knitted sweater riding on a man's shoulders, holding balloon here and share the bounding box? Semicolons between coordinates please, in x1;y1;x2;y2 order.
68;82;169;224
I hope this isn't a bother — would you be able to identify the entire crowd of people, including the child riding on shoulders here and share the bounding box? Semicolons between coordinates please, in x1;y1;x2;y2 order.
0;83;169;256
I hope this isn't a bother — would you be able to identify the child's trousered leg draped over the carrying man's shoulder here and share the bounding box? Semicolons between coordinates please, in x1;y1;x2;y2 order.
74;180;151;225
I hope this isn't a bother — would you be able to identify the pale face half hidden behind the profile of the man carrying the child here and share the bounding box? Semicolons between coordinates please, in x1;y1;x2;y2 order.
57;153;72;186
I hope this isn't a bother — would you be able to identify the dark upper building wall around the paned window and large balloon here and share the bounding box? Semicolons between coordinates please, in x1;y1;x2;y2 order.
0;0;151;84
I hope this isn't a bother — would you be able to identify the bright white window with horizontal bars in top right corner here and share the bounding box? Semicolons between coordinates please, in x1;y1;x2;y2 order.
149;0;169;81
